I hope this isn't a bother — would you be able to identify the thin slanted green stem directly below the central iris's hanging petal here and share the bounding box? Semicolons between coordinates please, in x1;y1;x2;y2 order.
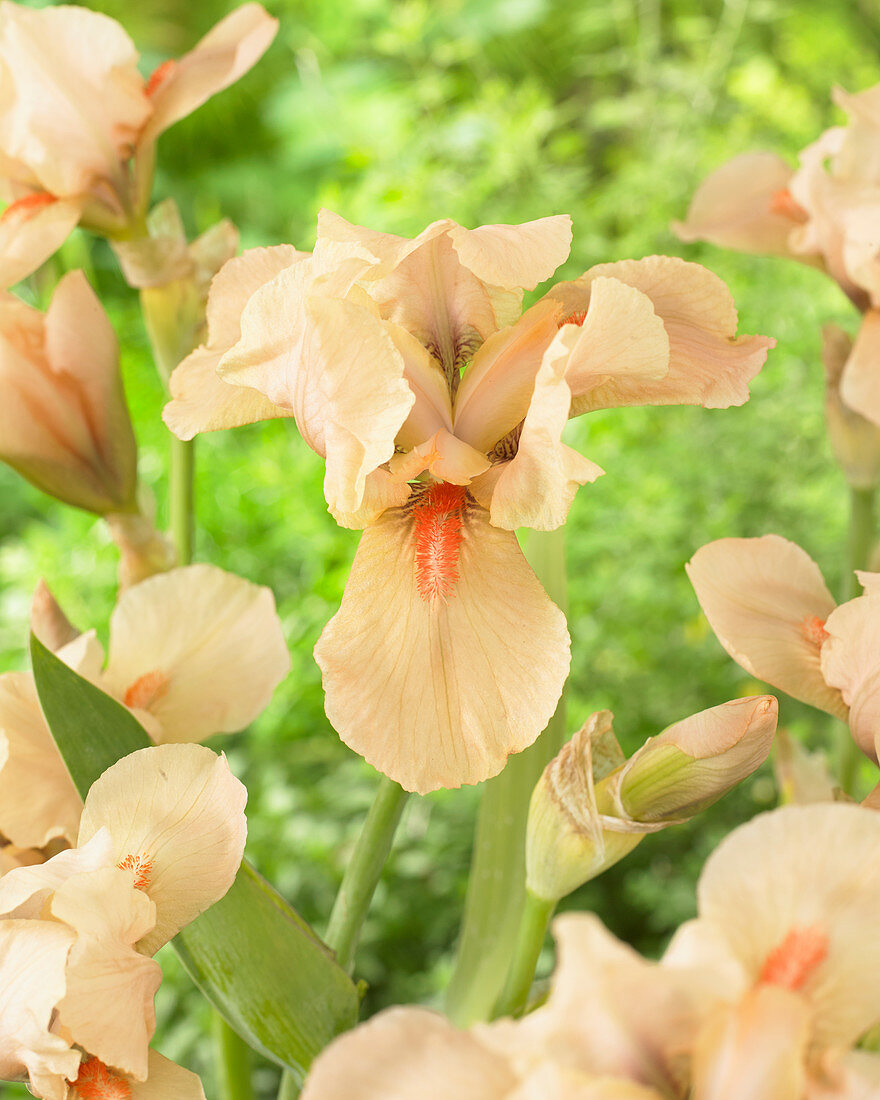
325;776;409;970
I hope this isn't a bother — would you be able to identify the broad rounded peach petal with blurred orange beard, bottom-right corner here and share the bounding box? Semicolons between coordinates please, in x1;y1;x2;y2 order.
697;802;880;1049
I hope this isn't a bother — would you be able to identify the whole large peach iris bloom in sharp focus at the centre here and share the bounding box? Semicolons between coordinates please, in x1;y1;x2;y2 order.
165;211;772;792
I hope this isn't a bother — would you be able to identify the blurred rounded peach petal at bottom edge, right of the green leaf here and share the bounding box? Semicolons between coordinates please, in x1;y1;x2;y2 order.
303;1008;516;1100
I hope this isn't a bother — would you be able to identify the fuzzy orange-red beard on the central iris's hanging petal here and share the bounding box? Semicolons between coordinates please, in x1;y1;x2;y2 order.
413;482;468;604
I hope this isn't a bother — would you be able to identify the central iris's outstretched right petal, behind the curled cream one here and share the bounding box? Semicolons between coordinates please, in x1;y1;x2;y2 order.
572;256;776;414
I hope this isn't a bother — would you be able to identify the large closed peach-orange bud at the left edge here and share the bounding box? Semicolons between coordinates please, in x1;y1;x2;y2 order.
0;272;138;515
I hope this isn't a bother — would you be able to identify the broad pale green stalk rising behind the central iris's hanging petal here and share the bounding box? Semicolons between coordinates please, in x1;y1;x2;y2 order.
446;528;568;1027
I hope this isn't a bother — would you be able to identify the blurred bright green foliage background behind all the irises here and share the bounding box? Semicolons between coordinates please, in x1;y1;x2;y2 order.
0;0;880;1100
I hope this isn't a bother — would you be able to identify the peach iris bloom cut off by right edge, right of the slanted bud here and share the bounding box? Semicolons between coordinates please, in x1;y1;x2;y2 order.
686;535;880;760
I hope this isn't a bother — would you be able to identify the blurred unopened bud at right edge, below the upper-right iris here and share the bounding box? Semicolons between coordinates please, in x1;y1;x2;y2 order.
822;325;880;488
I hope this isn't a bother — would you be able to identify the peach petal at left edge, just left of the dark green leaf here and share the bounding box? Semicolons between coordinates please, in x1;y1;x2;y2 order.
0;672;83;848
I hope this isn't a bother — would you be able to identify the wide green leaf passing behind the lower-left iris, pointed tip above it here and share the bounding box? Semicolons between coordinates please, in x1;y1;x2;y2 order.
31;636;360;1080
